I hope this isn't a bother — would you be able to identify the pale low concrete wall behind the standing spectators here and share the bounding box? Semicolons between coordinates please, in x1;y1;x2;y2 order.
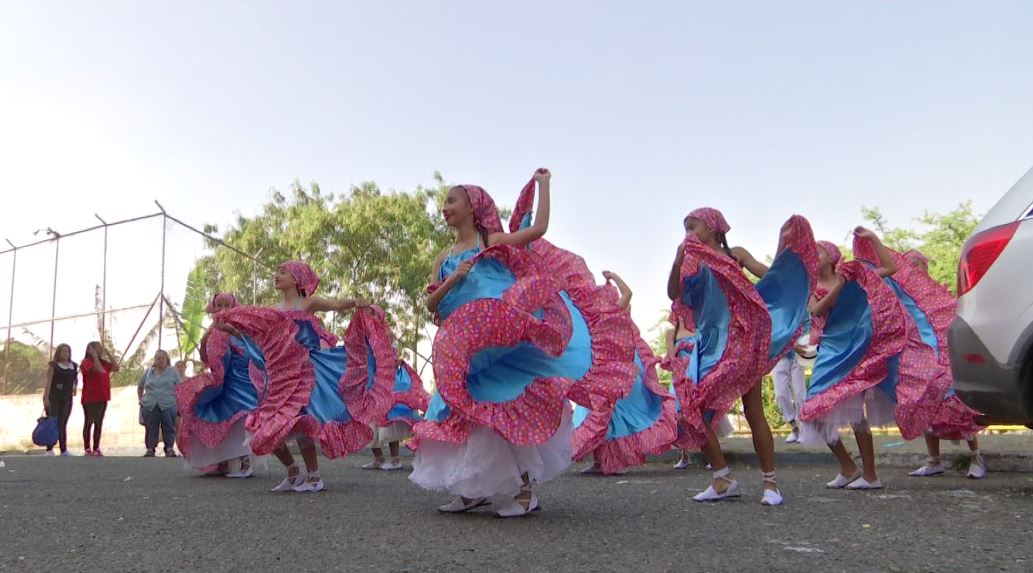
0;386;144;454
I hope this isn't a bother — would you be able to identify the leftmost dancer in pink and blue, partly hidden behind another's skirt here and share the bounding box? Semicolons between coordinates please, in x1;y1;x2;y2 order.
176;292;264;478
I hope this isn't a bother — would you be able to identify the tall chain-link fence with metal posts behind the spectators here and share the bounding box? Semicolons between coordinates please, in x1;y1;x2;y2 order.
0;201;269;394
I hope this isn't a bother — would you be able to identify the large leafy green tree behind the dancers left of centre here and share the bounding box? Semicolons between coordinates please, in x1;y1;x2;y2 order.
197;173;451;367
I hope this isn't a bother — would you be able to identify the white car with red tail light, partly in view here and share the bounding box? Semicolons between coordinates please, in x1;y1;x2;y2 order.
949;164;1033;426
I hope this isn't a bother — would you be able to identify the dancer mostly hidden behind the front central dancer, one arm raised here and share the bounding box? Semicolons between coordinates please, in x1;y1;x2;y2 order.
573;270;678;475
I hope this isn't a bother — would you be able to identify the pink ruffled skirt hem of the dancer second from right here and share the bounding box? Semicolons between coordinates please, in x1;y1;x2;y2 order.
800;260;908;422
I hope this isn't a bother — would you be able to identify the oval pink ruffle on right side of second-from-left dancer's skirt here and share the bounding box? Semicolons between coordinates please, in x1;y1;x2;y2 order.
338;307;398;423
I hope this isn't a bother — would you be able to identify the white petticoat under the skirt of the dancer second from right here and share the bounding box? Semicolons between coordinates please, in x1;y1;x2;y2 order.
800;388;897;446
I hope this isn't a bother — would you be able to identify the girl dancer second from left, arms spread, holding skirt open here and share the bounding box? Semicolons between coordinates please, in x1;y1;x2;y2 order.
213;261;396;492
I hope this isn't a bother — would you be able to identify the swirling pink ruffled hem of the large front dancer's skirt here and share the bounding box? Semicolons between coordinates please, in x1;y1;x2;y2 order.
414;174;636;445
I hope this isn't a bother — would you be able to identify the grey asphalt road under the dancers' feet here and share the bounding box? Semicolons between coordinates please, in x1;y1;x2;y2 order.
0;456;1033;573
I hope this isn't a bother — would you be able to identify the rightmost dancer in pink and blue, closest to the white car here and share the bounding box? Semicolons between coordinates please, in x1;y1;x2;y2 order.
854;242;987;479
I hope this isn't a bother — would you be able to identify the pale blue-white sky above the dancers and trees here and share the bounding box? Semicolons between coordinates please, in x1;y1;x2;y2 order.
0;1;1033;352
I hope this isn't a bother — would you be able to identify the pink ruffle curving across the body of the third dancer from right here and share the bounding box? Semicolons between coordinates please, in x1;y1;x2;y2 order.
671;234;772;447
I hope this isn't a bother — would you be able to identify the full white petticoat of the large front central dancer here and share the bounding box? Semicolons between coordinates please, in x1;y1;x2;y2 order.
409;408;573;502
